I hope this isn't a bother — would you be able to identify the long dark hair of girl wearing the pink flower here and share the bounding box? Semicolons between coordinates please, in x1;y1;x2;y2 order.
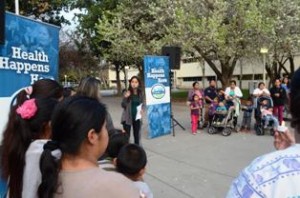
1;98;58;197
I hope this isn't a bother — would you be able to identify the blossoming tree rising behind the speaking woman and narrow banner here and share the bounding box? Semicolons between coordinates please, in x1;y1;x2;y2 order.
97;0;175;93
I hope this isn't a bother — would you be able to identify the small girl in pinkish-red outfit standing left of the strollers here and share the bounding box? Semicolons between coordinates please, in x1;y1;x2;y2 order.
190;94;201;135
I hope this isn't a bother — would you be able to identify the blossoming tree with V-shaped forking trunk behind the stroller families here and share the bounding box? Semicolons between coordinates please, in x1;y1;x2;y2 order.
169;0;266;87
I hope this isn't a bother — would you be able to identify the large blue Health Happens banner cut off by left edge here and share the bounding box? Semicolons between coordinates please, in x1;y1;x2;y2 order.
0;12;59;139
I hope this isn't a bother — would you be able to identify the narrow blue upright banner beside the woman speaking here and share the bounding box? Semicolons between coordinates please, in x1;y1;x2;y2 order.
144;56;171;138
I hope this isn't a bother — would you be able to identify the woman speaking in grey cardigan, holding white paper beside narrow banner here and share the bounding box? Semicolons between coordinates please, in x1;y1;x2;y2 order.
121;76;144;144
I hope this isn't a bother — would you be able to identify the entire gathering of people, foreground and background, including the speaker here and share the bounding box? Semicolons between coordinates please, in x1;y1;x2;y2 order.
1;67;300;198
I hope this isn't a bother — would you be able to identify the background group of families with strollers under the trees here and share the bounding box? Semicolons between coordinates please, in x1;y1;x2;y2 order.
187;77;290;135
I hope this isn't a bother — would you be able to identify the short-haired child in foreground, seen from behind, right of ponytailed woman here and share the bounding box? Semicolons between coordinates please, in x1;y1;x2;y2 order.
115;144;153;198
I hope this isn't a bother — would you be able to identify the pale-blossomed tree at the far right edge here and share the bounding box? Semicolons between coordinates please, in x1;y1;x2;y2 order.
260;0;300;82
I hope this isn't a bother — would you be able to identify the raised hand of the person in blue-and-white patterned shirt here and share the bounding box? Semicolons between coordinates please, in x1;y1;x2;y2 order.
274;130;296;150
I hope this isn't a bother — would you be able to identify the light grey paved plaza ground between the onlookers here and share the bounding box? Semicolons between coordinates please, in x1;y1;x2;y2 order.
103;97;290;198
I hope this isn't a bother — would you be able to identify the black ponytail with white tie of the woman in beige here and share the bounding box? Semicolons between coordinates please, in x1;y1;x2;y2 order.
38;141;61;198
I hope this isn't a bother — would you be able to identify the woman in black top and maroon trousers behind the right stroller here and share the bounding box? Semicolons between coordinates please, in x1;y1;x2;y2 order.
270;79;286;125
